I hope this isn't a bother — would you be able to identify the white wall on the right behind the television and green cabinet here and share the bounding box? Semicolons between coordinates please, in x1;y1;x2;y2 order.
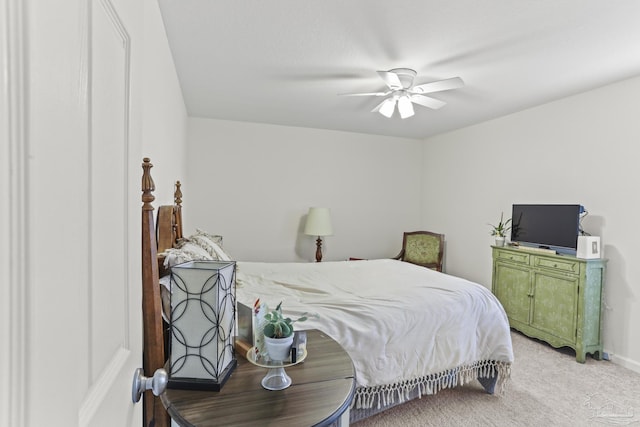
422;77;640;372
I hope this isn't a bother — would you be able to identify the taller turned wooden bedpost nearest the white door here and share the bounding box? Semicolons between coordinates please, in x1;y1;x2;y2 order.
142;157;170;427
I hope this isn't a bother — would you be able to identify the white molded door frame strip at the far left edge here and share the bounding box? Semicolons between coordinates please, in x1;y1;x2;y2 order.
0;0;29;426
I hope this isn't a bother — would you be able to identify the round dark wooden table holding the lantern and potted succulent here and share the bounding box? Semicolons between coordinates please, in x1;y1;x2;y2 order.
162;329;355;427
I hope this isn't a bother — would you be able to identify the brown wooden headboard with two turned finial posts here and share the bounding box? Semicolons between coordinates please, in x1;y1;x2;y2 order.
142;157;182;427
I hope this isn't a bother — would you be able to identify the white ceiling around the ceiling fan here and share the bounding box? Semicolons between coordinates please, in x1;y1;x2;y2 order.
159;0;640;138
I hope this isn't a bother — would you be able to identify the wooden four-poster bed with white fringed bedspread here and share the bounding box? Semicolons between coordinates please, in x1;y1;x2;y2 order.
143;159;513;425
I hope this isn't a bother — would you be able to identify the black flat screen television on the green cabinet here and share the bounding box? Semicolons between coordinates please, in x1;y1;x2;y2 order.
511;205;584;255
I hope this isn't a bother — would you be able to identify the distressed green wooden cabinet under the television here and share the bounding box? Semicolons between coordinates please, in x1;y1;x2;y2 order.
491;246;607;363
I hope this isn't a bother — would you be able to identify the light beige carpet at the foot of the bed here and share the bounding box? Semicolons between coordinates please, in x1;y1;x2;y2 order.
353;331;640;427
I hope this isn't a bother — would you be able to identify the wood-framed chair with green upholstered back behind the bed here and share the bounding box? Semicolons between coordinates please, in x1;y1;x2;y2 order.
395;231;444;271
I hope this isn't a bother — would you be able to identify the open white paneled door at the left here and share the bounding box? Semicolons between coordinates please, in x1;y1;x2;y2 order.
0;0;142;427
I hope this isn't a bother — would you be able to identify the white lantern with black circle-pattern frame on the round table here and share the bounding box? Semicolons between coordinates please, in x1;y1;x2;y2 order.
168;261;237;391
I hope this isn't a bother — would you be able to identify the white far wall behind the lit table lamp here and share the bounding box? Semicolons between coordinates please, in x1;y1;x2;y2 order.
183;118;422;262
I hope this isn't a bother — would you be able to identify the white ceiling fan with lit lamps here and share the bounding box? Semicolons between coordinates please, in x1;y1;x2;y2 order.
341;68;464;119
